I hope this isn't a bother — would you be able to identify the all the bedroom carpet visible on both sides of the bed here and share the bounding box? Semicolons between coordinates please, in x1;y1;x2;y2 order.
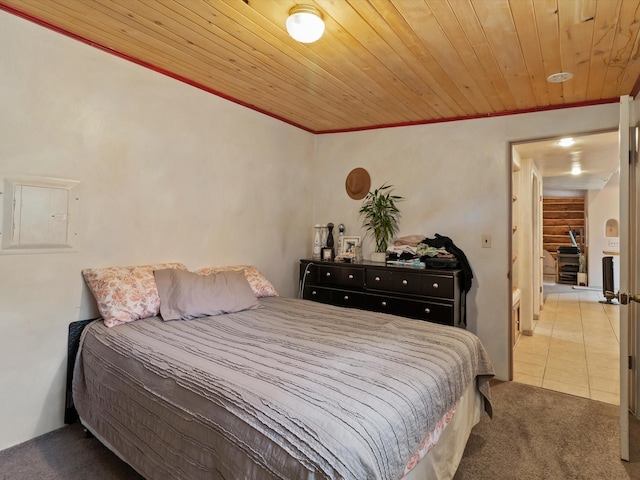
0;382;640;480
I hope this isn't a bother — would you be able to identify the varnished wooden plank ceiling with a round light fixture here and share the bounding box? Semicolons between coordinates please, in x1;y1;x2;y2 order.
0;0;640;133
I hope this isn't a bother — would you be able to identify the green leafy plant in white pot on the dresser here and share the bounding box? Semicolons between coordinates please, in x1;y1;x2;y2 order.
359;183;403;262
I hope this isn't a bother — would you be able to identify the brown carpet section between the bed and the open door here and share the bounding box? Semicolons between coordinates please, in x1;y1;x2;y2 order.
454;382;640;480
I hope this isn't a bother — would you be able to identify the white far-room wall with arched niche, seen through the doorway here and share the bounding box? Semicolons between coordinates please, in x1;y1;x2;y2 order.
586;172;620;292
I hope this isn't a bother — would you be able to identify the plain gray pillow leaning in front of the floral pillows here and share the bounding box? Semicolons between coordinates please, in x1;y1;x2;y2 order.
153;269;259;321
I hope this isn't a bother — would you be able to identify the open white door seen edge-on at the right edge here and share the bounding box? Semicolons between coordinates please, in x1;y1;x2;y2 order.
618;96;640;460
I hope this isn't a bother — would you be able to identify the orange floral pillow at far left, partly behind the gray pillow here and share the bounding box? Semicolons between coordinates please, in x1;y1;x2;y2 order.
82;263;187;327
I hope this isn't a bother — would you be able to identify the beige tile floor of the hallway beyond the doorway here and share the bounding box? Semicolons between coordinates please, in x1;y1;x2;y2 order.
513;287;620;405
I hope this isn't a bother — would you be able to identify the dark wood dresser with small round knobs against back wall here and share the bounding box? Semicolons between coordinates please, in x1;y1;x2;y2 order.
300;260;465;328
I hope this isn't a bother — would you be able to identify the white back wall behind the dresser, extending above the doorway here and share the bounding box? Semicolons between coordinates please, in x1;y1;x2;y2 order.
313;104;619;380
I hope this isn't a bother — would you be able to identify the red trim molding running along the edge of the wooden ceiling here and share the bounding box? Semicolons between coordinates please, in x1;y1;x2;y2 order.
0;1;640;135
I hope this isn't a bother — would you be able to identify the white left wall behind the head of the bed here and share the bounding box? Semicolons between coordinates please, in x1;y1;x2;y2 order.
0;12;314;449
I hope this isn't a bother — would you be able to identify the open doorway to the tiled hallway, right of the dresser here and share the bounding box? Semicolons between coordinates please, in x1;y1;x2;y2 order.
512;131;619;404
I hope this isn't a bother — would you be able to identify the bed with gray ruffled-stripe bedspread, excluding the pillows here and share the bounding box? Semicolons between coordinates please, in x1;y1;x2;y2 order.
73;264;493;480
